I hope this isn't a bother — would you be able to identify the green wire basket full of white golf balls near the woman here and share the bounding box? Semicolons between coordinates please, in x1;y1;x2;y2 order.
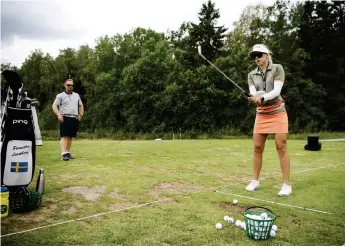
244;206;276;240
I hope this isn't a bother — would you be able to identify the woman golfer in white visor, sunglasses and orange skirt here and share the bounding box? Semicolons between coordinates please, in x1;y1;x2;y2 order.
246;44;292;196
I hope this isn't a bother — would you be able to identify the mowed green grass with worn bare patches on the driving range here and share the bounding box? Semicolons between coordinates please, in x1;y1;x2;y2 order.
1;140;344;245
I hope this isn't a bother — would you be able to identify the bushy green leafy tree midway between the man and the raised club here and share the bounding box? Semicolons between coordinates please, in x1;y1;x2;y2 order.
120;38;174;132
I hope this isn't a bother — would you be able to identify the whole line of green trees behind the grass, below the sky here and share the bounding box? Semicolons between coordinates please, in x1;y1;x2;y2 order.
1;0;345;135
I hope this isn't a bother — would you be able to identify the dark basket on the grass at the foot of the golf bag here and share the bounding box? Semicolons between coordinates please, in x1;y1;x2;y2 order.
9;186;42;213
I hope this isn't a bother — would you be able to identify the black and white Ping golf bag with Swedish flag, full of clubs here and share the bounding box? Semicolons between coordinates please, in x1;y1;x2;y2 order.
1;70;36;190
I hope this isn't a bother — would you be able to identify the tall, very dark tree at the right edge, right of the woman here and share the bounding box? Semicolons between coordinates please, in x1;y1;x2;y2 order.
298;1;345;130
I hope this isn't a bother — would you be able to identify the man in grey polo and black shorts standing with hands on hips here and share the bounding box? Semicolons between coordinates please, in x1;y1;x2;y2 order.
52;79;84;161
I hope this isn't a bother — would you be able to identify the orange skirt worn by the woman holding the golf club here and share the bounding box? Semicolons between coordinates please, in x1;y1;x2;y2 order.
253;111;289;134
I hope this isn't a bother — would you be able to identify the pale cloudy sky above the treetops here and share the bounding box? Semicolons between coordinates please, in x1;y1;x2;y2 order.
1;0;275;67
